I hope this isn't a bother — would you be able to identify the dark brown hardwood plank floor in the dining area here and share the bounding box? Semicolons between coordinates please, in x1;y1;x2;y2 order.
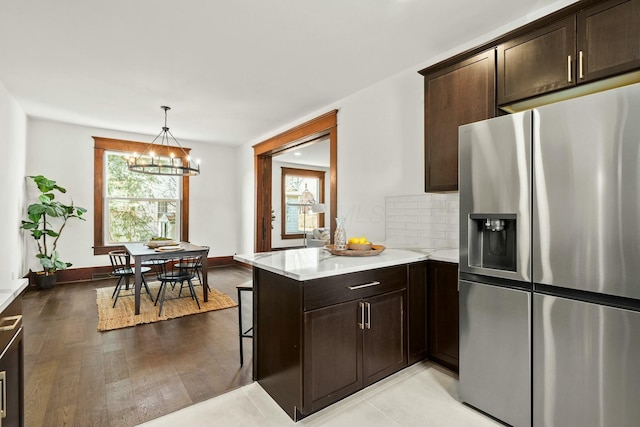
23;266;253;427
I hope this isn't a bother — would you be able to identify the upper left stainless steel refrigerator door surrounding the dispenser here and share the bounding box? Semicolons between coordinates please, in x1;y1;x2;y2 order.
459;111;531;282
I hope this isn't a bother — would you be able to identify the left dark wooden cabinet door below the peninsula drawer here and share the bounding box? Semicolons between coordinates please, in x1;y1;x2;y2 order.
302;301;363;414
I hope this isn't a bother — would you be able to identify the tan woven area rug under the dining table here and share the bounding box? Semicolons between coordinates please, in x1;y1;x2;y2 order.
96;282;238;331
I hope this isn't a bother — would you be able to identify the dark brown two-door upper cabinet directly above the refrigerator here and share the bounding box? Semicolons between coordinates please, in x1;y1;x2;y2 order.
497;0;640;106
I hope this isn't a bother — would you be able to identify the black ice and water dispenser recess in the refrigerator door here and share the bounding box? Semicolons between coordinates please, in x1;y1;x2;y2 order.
469;214;517;271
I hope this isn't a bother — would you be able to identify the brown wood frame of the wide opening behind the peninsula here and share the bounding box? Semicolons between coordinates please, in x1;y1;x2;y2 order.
253;110;338;252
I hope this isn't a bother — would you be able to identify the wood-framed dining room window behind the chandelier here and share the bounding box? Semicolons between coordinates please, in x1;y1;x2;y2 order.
93;137;189;255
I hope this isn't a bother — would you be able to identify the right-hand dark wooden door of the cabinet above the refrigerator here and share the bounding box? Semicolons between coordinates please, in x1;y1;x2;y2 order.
577;0;640;82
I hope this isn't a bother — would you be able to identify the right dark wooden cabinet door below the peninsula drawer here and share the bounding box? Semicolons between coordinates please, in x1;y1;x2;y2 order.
362;290;407;386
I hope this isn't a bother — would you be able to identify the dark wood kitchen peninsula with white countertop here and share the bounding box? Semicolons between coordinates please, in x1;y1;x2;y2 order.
234;248;427;420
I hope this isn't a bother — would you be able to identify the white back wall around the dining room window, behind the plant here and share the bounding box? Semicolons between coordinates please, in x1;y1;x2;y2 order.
26;119;238;269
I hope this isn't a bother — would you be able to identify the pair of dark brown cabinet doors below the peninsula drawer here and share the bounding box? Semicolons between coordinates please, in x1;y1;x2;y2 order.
304;291;406;413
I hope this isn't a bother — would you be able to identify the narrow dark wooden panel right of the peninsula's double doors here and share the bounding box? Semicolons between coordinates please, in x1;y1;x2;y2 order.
407;262;427;363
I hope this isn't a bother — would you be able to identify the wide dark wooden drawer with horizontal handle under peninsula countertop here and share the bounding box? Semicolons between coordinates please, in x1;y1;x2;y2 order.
303;265;407;311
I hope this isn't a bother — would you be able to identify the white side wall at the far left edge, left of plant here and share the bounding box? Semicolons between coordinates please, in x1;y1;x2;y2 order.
0;82;27;283
